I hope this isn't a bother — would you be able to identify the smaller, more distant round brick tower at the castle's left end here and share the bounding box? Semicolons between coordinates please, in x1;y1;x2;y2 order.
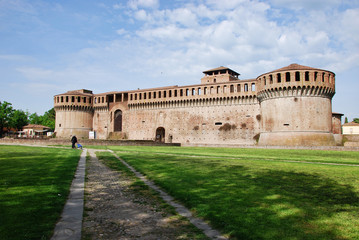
54;89;93;138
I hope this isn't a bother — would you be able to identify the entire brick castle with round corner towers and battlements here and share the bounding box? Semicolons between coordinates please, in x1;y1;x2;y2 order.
54;64;341;146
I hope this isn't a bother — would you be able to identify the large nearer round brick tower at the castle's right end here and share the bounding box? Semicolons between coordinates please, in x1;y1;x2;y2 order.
257;64;335;146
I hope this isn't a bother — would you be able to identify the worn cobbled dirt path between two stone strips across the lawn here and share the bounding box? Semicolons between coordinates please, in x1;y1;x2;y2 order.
82;150;207;240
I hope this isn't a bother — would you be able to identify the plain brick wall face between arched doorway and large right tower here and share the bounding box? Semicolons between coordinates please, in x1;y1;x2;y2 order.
125;103;260;144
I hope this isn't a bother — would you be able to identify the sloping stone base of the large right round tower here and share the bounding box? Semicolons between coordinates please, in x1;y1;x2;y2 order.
258;132;336;146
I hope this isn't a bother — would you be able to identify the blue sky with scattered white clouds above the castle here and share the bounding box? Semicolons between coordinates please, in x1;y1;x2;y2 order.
0;0;359;120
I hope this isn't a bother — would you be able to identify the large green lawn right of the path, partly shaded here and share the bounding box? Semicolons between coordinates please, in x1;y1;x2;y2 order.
109;146;359;240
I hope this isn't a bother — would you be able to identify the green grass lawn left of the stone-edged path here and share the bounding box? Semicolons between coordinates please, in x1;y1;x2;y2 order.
0;145;81;240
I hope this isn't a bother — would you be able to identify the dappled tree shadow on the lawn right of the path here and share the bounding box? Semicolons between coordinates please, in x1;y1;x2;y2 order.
117;153;359;240
